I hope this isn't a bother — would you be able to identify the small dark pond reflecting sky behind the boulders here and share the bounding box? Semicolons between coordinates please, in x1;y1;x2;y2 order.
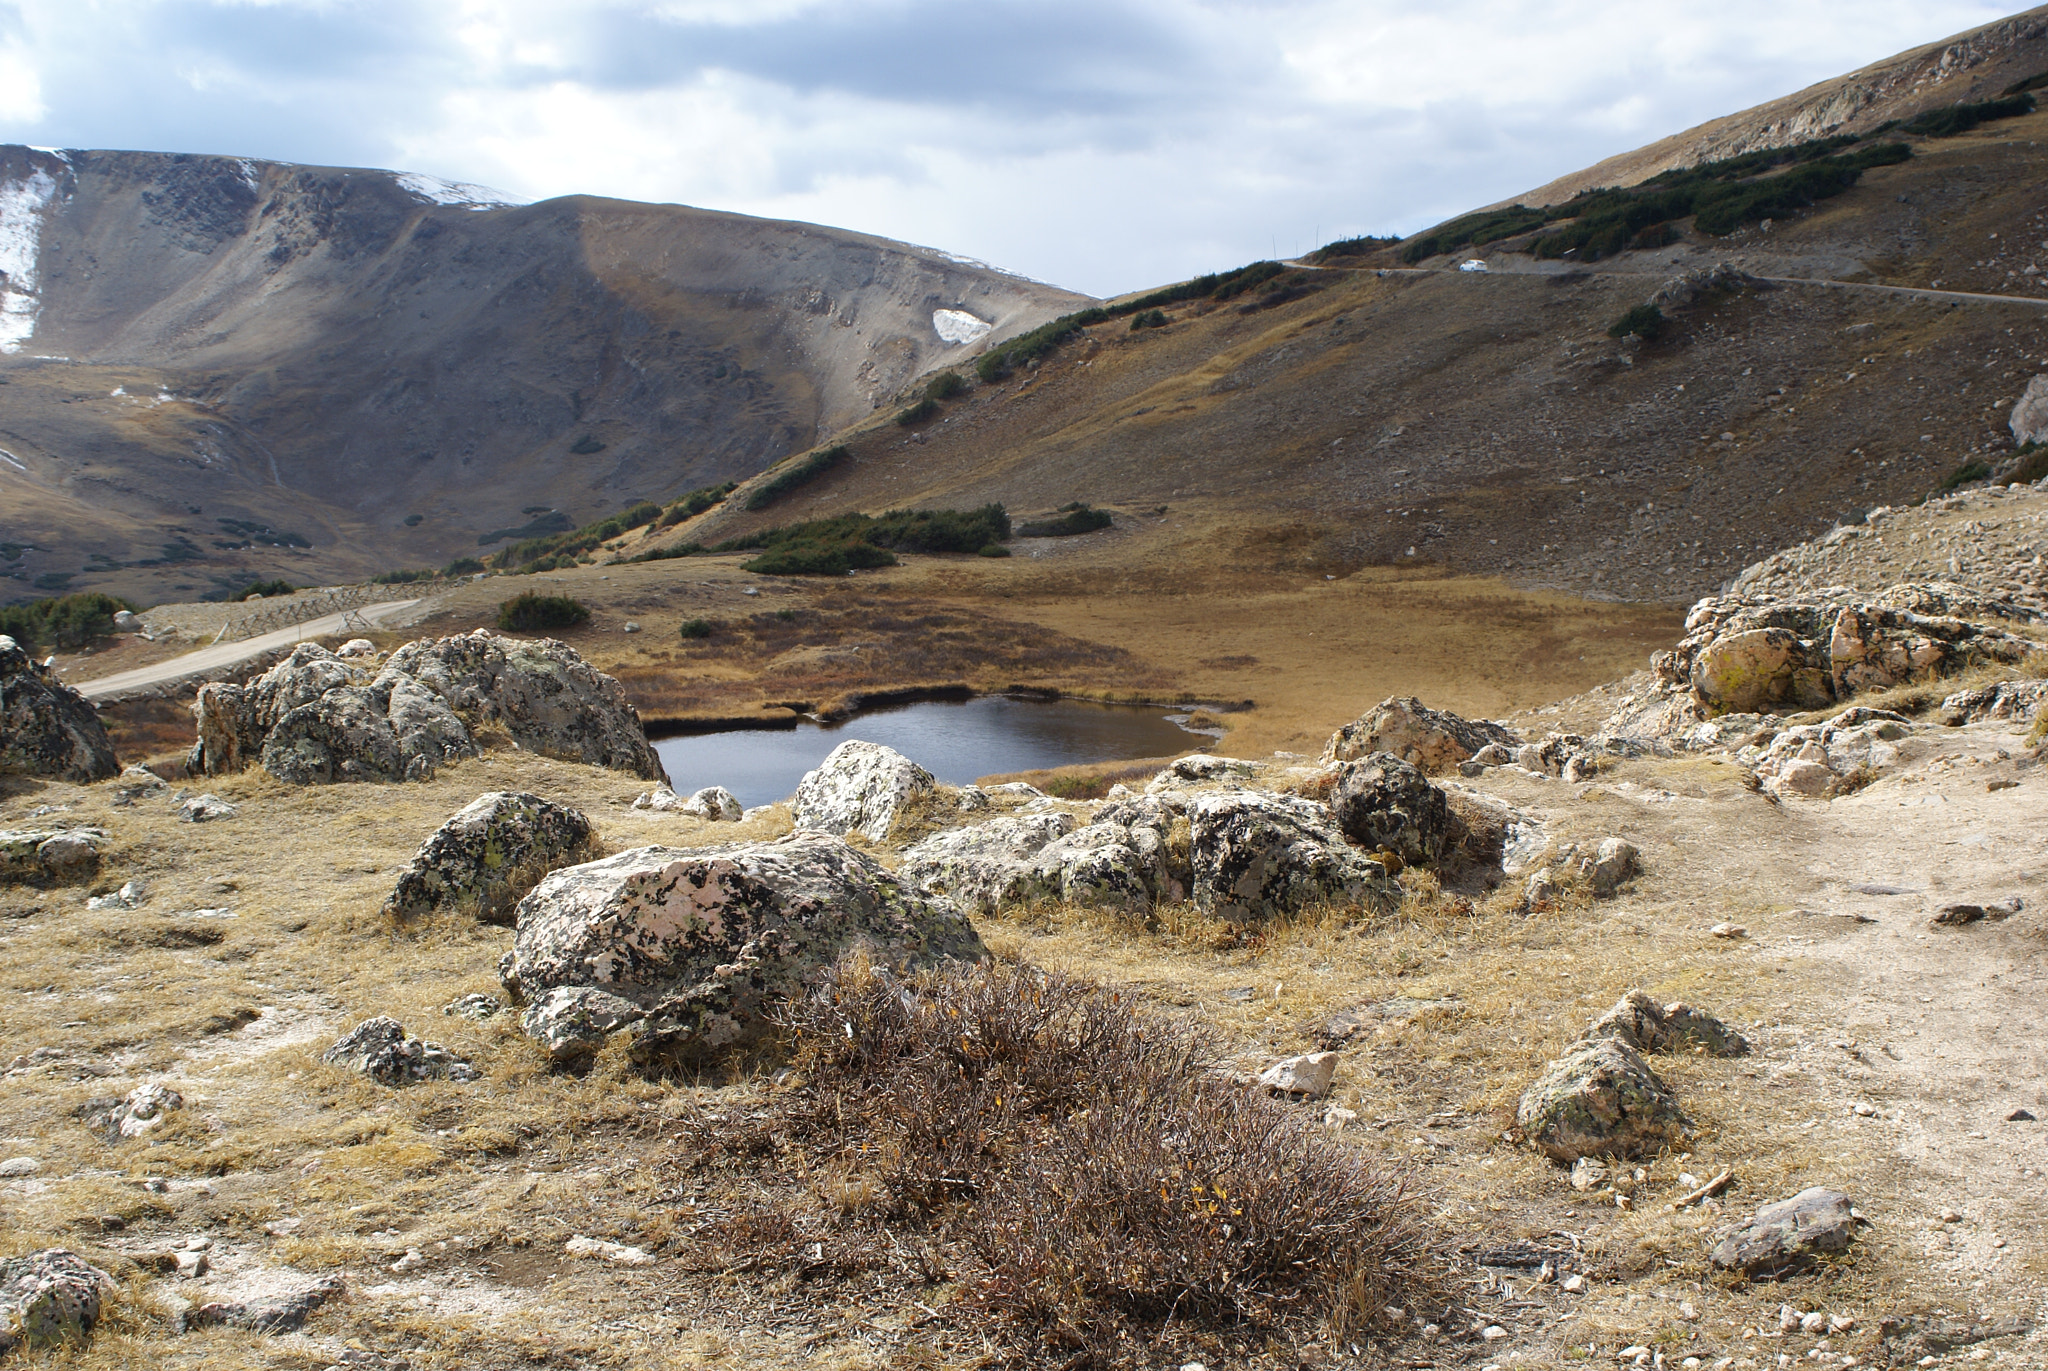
653;695;1206;805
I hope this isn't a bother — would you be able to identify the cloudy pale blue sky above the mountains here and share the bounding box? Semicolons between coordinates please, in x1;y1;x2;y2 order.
0;0;2011;295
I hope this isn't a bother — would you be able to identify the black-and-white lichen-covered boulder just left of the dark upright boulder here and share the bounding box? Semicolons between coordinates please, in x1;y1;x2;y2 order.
1188;791;1397;922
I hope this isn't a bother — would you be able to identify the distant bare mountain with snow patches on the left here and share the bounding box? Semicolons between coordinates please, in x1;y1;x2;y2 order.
0;146;1087;598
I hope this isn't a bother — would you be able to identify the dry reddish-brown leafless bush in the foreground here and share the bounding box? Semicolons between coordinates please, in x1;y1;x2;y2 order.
784;959;1427;1365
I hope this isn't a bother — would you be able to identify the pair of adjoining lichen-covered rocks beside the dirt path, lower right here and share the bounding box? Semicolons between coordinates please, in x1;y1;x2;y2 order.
1516;990;1749;1162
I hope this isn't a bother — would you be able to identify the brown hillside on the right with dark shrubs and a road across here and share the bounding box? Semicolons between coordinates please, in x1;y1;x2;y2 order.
676;8;2048;600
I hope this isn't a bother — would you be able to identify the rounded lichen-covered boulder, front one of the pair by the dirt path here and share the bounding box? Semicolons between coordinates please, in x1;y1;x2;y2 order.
1516;1037;1692;1162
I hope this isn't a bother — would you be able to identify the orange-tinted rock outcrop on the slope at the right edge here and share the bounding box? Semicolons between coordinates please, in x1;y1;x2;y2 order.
1651;586;2040;715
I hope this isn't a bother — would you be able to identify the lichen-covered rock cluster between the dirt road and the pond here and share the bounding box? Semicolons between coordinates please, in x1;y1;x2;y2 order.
188;629;662;785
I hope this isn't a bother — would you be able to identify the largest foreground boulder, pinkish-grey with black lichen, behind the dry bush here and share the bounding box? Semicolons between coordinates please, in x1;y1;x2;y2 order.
512;832;985;1060
